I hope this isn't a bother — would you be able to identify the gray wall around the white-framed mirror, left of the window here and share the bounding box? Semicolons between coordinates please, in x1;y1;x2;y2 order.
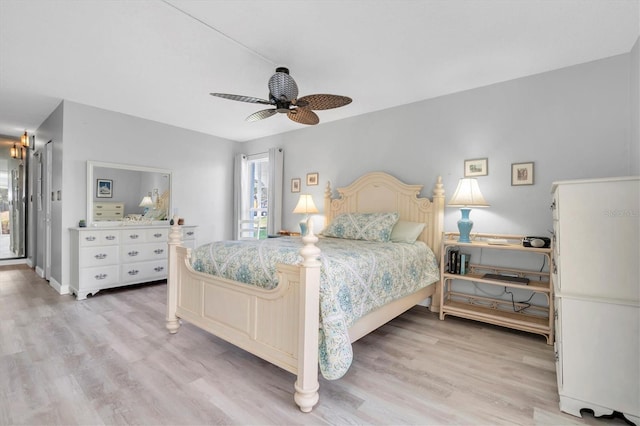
43;101;234;286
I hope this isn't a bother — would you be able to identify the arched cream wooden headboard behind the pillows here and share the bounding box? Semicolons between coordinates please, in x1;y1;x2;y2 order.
324;172;444;257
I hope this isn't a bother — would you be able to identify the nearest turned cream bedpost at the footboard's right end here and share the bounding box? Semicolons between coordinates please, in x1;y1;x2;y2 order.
294;220;320;413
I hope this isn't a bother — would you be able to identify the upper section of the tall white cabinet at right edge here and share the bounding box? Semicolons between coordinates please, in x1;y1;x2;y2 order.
554;180;640;301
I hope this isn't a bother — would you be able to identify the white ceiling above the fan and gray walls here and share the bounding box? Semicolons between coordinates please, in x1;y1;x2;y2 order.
0;0;640;141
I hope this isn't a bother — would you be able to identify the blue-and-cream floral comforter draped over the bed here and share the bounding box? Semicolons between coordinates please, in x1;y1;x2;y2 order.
191;238;440;380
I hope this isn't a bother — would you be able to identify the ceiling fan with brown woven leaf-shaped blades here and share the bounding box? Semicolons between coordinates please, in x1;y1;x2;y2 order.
210;67;351;124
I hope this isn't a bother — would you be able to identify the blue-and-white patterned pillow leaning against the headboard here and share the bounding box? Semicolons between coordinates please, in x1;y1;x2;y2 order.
322;213;400;242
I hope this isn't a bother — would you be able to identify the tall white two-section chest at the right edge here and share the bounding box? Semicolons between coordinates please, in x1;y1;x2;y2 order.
552;177;640;424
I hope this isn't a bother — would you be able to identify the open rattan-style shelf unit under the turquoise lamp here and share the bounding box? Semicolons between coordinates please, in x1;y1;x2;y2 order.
439;232;554;345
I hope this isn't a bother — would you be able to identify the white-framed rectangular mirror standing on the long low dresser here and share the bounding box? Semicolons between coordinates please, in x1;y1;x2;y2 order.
87;161;172;226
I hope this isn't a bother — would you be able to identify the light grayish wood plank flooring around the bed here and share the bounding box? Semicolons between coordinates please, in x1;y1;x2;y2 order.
0;266;624;425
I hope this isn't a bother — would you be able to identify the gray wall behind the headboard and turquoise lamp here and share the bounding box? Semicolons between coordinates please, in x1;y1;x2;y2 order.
240;53;639;235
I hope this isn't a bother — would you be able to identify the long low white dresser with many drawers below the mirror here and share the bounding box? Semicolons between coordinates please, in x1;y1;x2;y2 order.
70;225;196;300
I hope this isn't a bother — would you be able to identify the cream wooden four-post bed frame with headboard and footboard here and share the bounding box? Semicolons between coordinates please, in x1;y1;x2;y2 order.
167;172;444;412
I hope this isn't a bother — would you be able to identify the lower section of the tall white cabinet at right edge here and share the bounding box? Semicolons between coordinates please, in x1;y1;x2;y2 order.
558;297;640;415
